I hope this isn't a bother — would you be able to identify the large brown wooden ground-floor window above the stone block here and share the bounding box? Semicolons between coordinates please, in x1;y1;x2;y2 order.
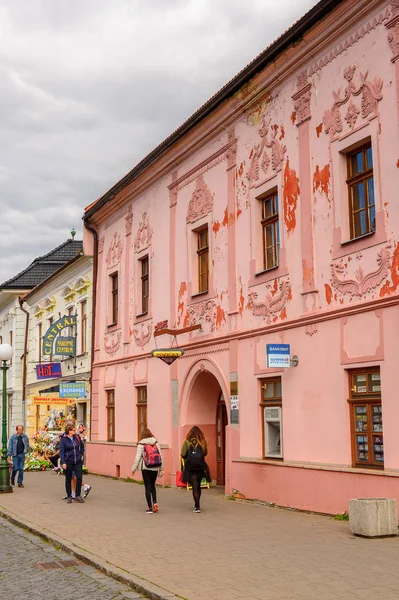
349;368;384;468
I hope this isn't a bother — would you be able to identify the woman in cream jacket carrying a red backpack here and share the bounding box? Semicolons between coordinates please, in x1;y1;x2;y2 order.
132;428;163;515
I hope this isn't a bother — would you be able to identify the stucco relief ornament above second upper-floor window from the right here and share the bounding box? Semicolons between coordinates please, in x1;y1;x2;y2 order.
247;119;287;184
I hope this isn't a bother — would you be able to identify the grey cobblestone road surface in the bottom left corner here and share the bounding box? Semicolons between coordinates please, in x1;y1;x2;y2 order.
0;517;144;600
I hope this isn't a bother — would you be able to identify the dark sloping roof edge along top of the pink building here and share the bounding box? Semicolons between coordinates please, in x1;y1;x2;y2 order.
82;0;344;221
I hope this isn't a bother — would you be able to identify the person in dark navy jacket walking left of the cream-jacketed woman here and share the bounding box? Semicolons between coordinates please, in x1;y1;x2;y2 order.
60;423;84;504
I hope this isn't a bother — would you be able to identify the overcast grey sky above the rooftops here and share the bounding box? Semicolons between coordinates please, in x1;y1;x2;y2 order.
0;0;316;283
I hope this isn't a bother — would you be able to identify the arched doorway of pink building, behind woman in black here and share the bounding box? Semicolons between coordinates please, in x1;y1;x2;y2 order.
180;360;228;485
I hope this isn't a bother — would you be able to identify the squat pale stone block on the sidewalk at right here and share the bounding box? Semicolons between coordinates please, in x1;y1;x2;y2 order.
349;498;398;537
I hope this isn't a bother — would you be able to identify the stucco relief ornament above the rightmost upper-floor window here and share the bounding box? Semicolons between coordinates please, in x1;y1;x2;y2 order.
323;66;383;138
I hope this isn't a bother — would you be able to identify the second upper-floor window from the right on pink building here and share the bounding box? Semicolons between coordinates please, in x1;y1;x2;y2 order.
262;192;280;271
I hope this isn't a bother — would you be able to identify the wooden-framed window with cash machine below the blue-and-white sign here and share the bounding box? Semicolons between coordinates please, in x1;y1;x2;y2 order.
260;377;283;458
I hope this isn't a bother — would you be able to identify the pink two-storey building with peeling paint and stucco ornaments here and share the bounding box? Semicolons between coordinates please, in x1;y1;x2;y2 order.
85;0;399;513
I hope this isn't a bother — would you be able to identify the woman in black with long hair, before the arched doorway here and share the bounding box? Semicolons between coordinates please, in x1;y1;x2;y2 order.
180;425;208;513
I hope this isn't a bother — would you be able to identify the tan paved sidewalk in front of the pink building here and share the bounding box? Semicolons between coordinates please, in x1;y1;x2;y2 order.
0;471;399;600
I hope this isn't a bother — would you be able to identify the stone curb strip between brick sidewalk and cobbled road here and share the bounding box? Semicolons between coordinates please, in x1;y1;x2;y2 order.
0;508;182;600
